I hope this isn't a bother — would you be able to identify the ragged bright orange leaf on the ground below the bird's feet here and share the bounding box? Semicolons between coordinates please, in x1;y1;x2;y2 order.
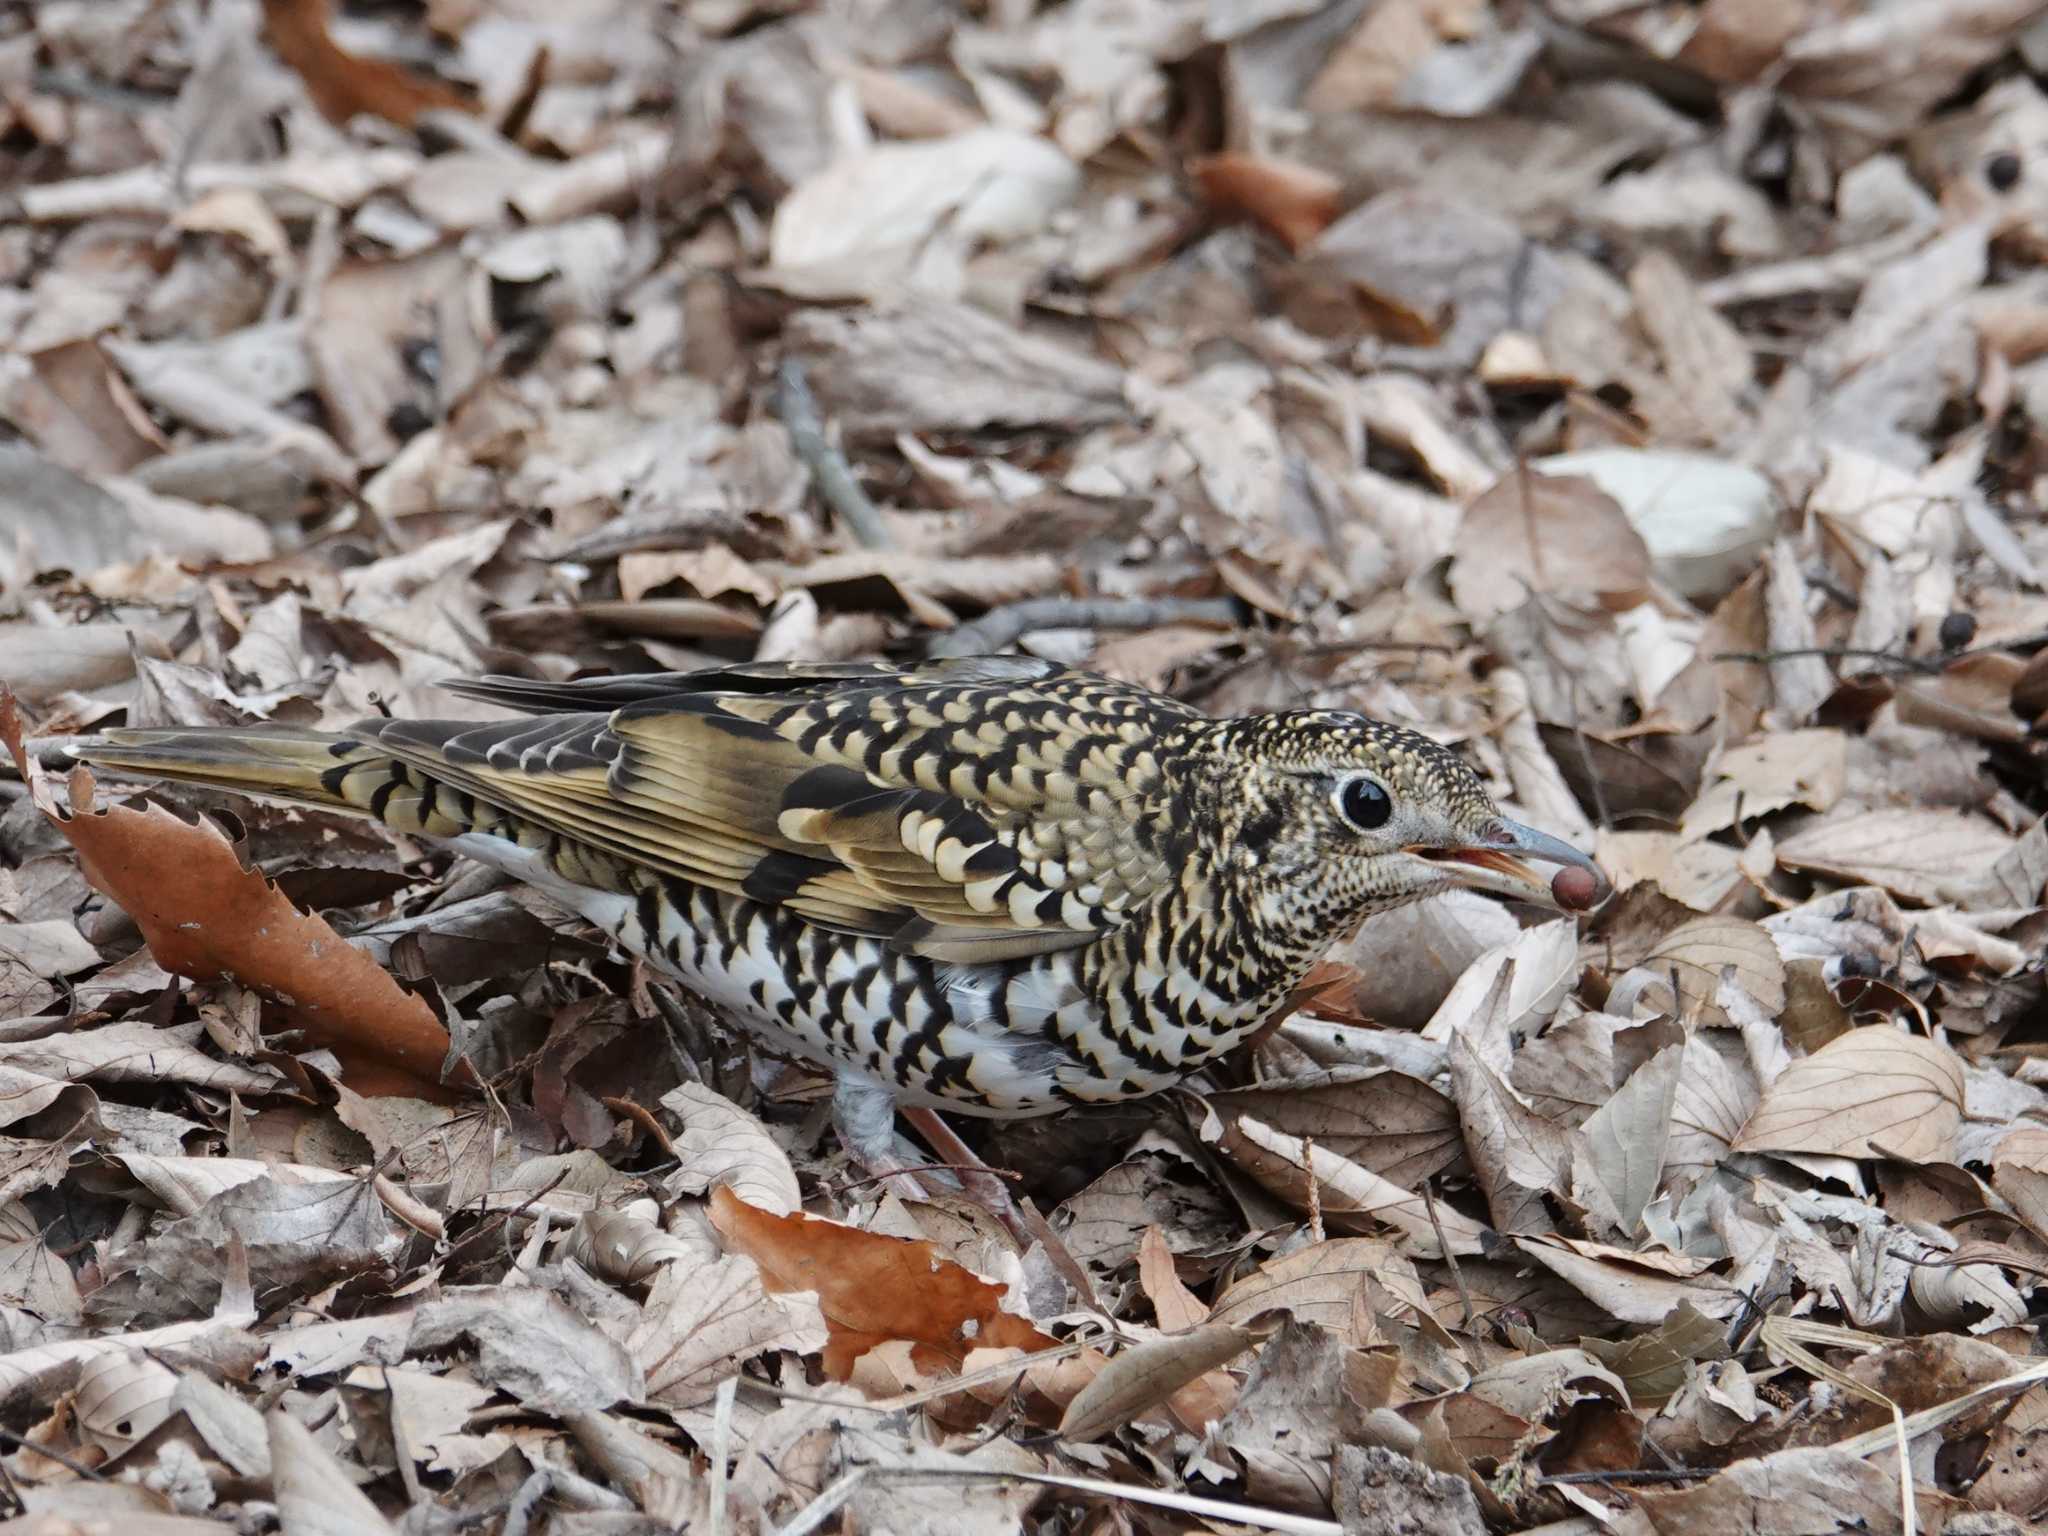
711;1184;1055;1380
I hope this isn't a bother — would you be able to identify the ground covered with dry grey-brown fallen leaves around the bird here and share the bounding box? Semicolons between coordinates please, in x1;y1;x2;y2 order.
0;0;2048;1536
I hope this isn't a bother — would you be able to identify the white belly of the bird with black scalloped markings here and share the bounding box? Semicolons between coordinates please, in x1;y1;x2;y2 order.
451;834;1264;1118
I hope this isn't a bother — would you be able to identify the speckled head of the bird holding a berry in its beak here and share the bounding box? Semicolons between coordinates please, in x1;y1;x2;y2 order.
1214;711;1614;934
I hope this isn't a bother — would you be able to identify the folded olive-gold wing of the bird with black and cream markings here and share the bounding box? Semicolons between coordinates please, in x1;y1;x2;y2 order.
370;657;1196;961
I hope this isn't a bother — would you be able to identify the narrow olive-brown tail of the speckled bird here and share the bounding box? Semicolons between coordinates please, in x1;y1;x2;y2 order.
33;725;473;838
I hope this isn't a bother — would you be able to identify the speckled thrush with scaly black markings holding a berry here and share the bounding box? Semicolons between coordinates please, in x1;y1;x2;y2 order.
39;655;1612;1204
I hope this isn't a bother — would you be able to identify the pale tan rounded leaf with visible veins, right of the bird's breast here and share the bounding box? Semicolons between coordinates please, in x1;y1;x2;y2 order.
1733;1024;1964;1163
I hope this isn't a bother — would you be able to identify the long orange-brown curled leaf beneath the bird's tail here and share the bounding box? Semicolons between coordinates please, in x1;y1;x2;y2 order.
0;686;464;1098
